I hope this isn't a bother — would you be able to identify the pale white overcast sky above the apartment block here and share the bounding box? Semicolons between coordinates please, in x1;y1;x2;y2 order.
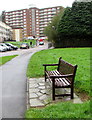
0;0;75;13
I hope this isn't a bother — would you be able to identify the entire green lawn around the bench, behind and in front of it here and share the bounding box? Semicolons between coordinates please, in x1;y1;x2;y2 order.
25;48;92;118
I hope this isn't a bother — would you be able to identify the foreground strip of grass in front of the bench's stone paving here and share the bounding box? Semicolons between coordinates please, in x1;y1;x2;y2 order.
25;101;91;120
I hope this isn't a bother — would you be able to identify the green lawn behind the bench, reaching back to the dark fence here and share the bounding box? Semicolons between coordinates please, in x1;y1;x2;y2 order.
27;48;90;94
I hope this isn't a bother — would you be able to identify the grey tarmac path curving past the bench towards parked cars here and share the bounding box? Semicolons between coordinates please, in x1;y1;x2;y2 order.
0;45;47;118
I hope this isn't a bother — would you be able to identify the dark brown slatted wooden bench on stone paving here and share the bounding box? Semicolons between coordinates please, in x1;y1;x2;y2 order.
43;57;77;100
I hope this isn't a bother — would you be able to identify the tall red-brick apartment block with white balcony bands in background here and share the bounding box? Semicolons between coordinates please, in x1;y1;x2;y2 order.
5;6;63;38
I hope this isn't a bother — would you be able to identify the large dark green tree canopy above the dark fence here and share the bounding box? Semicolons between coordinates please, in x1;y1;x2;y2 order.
58;2;92;36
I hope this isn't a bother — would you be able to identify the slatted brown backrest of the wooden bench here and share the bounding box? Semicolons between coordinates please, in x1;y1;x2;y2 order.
57;57;77;82
